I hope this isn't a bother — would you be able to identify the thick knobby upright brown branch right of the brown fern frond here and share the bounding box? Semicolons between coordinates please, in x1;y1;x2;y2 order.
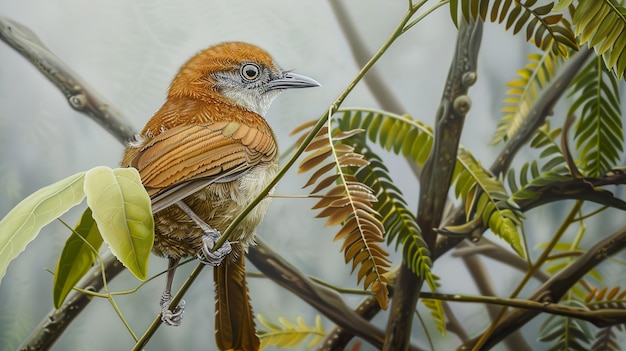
383;22;482;351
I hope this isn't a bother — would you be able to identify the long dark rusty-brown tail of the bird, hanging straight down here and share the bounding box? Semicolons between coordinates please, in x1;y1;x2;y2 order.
213;248;260;351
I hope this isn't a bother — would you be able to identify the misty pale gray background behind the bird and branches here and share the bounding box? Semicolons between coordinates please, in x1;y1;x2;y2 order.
0;0;625;350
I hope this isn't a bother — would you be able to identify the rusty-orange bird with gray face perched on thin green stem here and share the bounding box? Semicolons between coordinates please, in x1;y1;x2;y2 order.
121;41;320;351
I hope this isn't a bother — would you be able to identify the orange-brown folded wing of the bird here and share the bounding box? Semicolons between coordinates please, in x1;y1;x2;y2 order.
127;121;277;213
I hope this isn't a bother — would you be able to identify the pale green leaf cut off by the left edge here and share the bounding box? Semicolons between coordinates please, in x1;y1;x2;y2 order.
0;172;85;288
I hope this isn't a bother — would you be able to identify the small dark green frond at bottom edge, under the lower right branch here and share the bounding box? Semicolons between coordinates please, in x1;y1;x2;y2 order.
539;300;593;351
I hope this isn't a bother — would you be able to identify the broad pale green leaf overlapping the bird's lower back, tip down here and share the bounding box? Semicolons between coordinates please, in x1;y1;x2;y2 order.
85;167;154;280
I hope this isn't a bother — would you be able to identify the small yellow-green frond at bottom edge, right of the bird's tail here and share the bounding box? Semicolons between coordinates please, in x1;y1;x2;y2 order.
257;314;326;349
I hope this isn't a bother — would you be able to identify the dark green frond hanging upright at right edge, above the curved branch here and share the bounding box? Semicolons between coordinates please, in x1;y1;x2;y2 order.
569;57;624;177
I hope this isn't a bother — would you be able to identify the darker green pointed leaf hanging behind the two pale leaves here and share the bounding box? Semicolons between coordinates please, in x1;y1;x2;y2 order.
53;207;102;308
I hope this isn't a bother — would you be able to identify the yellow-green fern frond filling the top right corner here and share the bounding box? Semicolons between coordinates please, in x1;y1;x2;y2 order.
573;0;626;79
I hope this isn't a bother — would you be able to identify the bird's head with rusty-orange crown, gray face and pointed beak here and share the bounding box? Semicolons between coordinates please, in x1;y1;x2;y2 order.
169;42;320;116
